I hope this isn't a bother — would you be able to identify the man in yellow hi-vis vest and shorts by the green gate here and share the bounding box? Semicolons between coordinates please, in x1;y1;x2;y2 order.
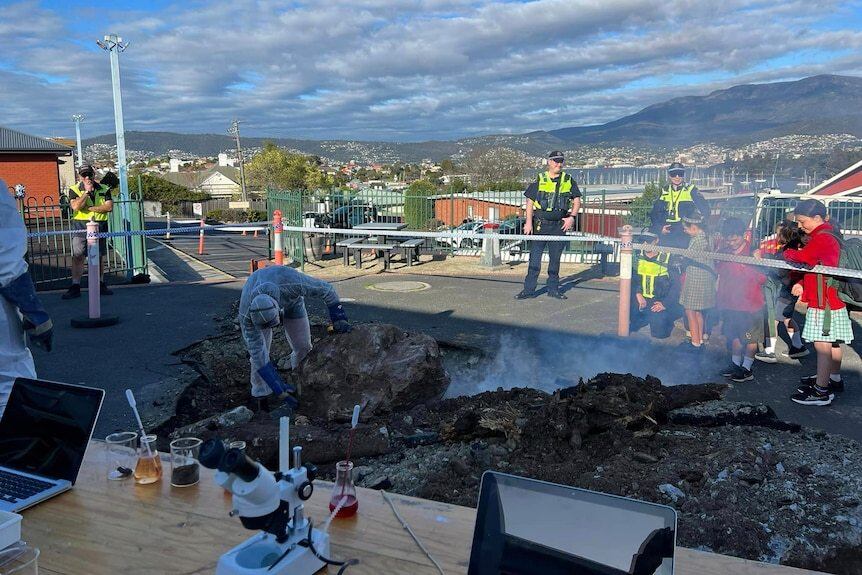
63;165;114;299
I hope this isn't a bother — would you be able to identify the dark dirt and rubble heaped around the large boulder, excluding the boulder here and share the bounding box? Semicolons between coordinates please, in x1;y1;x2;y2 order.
160;328;862;575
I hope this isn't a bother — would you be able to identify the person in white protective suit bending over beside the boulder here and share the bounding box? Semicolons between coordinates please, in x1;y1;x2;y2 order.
239;266;351;409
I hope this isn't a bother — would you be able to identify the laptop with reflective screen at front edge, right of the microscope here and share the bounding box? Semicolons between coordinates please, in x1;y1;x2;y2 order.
468;471;677;575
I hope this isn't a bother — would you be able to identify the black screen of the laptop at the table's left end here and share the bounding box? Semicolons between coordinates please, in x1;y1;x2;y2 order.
0;377;105;483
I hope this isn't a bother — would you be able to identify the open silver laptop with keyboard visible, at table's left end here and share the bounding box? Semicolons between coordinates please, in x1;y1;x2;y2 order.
0;377;105;511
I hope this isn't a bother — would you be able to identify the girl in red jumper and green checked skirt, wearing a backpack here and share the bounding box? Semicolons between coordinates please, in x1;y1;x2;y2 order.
784;199;853;406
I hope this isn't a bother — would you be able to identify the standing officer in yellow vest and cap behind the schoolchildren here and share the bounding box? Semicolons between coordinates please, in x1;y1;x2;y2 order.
650;162;709;248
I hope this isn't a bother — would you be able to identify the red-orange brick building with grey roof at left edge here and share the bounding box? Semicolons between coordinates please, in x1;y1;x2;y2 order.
0;126;72;204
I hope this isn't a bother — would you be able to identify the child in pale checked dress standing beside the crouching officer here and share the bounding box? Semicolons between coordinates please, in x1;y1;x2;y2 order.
679;209;716;352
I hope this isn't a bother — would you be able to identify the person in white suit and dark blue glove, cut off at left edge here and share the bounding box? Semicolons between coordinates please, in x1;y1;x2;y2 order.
0;180;54;415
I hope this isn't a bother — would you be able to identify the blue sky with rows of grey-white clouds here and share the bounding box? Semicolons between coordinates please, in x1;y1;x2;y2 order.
0;0;862;142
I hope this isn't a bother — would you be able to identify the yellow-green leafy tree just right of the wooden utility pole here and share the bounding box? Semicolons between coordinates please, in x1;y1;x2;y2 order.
250;142;330;190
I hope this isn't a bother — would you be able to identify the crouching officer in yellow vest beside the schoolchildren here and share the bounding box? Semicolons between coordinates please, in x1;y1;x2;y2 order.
629;229;682;339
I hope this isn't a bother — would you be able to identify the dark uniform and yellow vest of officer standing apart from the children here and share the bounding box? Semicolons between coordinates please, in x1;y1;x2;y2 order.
524;172;581;293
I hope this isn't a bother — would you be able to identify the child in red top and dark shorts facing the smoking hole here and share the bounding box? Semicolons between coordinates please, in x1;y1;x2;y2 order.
715;218;766;382
